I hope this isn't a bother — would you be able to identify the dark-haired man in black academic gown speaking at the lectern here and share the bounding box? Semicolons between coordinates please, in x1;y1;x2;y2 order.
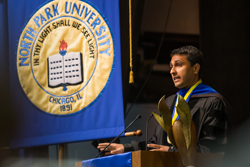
97;46;231;155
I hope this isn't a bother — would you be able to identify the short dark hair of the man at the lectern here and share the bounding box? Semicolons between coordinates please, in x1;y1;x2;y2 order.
170;45;203;76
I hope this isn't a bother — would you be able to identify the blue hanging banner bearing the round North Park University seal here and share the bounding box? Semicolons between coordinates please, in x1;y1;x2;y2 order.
8;0;124;148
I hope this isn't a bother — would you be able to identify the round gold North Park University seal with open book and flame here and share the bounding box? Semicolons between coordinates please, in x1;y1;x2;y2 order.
17;0;115;115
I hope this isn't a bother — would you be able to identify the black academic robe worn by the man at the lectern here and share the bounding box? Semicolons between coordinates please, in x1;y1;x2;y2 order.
124;93;231;152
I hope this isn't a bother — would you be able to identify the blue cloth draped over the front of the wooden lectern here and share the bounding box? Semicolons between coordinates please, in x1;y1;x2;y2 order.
82;152;132;167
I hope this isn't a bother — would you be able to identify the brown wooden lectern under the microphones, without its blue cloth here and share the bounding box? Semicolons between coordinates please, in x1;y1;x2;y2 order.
75;151;222;167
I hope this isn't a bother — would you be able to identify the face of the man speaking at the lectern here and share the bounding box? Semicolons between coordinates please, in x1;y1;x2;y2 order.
170;54;199;89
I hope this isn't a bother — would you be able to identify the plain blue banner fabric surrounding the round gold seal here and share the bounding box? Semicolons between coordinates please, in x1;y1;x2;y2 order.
8;0;124;148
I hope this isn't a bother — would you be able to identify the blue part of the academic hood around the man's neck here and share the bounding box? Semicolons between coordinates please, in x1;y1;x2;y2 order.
172;83;218;119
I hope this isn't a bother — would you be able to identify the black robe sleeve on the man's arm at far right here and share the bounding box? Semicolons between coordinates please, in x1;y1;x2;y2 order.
196;97;228;152
